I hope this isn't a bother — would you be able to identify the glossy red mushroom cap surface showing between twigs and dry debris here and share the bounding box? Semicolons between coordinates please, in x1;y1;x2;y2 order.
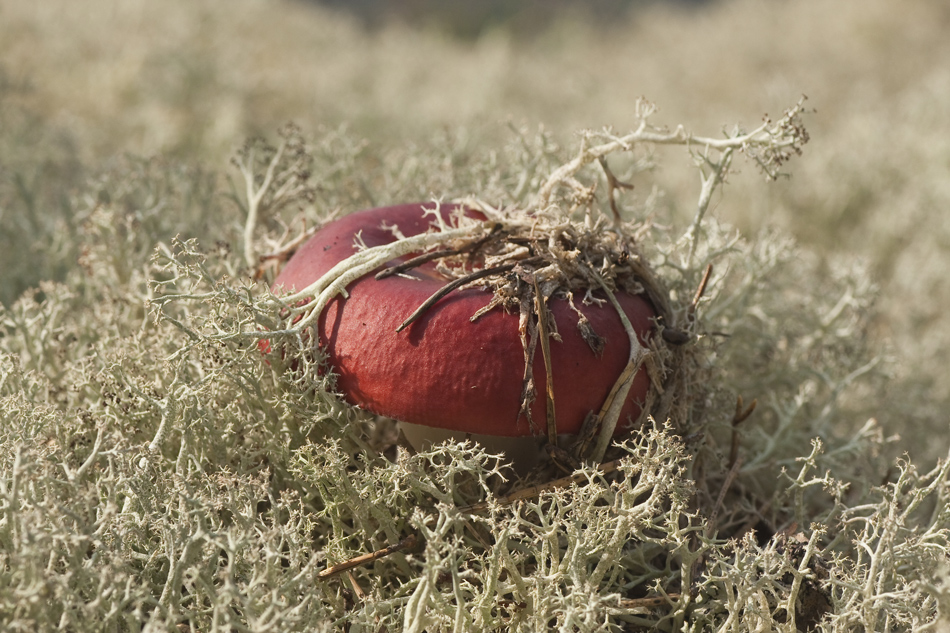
274;203;655;436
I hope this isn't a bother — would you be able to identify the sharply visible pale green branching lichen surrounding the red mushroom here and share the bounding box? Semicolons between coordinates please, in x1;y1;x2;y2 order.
0;104;950;631
